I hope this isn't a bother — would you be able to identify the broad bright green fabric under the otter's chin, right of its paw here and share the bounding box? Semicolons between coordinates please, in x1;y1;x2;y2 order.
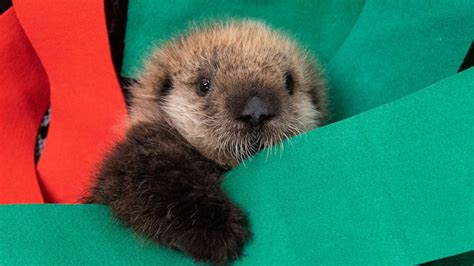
224;69;474;265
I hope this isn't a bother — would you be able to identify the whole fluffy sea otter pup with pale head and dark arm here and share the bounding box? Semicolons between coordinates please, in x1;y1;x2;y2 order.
87;21;326;264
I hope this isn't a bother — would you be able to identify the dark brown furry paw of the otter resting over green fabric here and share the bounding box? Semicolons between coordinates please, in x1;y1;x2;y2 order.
169;193;250;265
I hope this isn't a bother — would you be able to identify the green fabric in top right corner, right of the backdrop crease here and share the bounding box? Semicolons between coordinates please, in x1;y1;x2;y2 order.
328;0;474;120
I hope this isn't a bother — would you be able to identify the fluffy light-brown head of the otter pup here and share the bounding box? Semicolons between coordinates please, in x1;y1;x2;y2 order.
131;21;326;166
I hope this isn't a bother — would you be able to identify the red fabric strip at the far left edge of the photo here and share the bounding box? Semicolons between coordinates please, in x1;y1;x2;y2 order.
0;9;49;203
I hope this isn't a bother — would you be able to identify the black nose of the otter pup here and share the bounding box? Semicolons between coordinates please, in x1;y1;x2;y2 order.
238;96;274;128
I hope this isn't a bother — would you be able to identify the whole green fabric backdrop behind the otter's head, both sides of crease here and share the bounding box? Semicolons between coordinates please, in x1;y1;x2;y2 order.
122;0;474;120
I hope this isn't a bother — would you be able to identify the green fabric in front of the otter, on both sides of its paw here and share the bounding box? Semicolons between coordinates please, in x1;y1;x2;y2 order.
0;69;474;265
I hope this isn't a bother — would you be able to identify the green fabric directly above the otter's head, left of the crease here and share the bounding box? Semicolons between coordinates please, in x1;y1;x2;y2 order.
122;0;364;78
